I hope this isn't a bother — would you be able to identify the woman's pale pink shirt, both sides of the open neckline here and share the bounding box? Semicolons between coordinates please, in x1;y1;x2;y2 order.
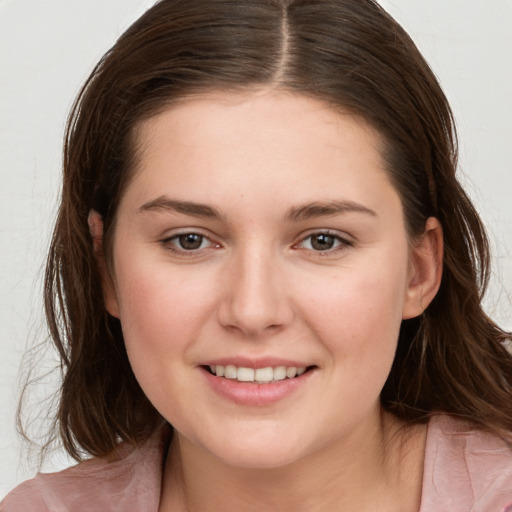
0;416;512;512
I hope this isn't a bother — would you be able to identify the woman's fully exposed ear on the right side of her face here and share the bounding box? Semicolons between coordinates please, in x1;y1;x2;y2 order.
402;217;443;320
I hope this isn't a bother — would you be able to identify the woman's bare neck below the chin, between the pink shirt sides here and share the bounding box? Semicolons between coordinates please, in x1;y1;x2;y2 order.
160;413;426;512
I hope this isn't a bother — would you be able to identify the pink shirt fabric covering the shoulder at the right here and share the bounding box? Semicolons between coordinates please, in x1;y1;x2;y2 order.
421;415;512;512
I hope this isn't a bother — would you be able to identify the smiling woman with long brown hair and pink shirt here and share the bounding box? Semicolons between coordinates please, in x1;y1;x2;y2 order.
3;0;512;512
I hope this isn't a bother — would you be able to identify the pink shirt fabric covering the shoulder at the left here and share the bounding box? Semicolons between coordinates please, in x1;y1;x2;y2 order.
0;431;168;512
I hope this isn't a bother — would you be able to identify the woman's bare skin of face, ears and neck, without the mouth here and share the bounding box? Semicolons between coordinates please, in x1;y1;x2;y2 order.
91;91;442;511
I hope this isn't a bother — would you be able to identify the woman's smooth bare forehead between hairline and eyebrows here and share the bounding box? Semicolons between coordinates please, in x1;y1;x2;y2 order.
128;91;400;219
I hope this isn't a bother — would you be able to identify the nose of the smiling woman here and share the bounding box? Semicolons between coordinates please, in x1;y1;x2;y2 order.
218;248;293;338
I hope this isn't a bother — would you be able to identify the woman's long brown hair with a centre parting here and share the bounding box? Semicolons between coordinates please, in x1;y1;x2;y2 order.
33;0;512;459
